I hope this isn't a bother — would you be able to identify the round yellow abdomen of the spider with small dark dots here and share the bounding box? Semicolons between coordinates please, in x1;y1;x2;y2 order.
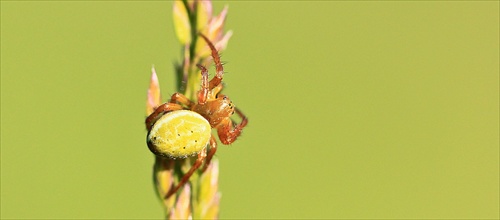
147;110;211;158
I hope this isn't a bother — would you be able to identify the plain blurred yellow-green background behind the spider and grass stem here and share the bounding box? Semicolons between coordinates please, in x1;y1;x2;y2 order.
1;1;499;219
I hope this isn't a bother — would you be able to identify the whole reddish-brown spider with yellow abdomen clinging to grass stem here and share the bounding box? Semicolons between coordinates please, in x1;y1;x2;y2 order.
146;34;248;199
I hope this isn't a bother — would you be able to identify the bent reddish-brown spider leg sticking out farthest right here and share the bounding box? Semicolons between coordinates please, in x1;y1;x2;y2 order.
217;108;248;145
